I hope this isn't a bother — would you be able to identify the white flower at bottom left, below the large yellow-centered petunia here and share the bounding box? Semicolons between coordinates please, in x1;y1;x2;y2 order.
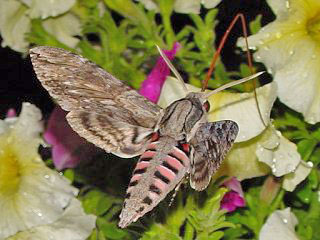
7;198;96;240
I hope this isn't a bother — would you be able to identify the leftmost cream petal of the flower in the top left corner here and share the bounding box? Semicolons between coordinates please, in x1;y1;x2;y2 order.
0;0;31;52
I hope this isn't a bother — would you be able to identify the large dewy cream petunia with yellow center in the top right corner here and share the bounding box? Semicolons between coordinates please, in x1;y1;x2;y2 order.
238;0;320;124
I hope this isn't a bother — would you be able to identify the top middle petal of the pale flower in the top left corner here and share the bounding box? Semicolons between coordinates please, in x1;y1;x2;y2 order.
21;0;75;19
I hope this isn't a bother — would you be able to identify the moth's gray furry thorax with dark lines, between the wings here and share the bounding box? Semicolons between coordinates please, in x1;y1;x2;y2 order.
159;95;207;140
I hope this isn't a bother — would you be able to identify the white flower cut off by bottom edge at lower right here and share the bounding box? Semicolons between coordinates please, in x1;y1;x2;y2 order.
259;208;299;240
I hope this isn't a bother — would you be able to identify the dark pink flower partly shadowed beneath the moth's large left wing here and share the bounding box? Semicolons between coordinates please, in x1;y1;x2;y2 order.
44;107;98;170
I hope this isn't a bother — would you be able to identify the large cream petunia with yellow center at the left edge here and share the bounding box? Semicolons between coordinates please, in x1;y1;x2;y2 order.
0;103;78;239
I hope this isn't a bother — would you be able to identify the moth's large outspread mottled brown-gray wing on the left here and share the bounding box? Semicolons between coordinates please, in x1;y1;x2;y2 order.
30;47;161;157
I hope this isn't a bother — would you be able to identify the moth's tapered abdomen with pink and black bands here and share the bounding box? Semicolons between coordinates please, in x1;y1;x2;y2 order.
119;137;190;228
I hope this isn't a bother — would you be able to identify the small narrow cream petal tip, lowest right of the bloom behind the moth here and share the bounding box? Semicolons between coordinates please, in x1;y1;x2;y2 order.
282;160;312;192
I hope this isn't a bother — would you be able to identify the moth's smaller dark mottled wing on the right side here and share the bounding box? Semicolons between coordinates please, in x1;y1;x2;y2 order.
190;120;239;191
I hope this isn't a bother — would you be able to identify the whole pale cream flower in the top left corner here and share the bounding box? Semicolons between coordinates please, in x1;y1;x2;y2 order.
0;0;81;52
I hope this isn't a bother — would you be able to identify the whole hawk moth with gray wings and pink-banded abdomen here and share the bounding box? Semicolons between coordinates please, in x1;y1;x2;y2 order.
30;46;260;228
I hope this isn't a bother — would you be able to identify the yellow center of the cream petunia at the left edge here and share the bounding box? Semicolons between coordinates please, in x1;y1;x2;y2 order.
0;143;20;196
